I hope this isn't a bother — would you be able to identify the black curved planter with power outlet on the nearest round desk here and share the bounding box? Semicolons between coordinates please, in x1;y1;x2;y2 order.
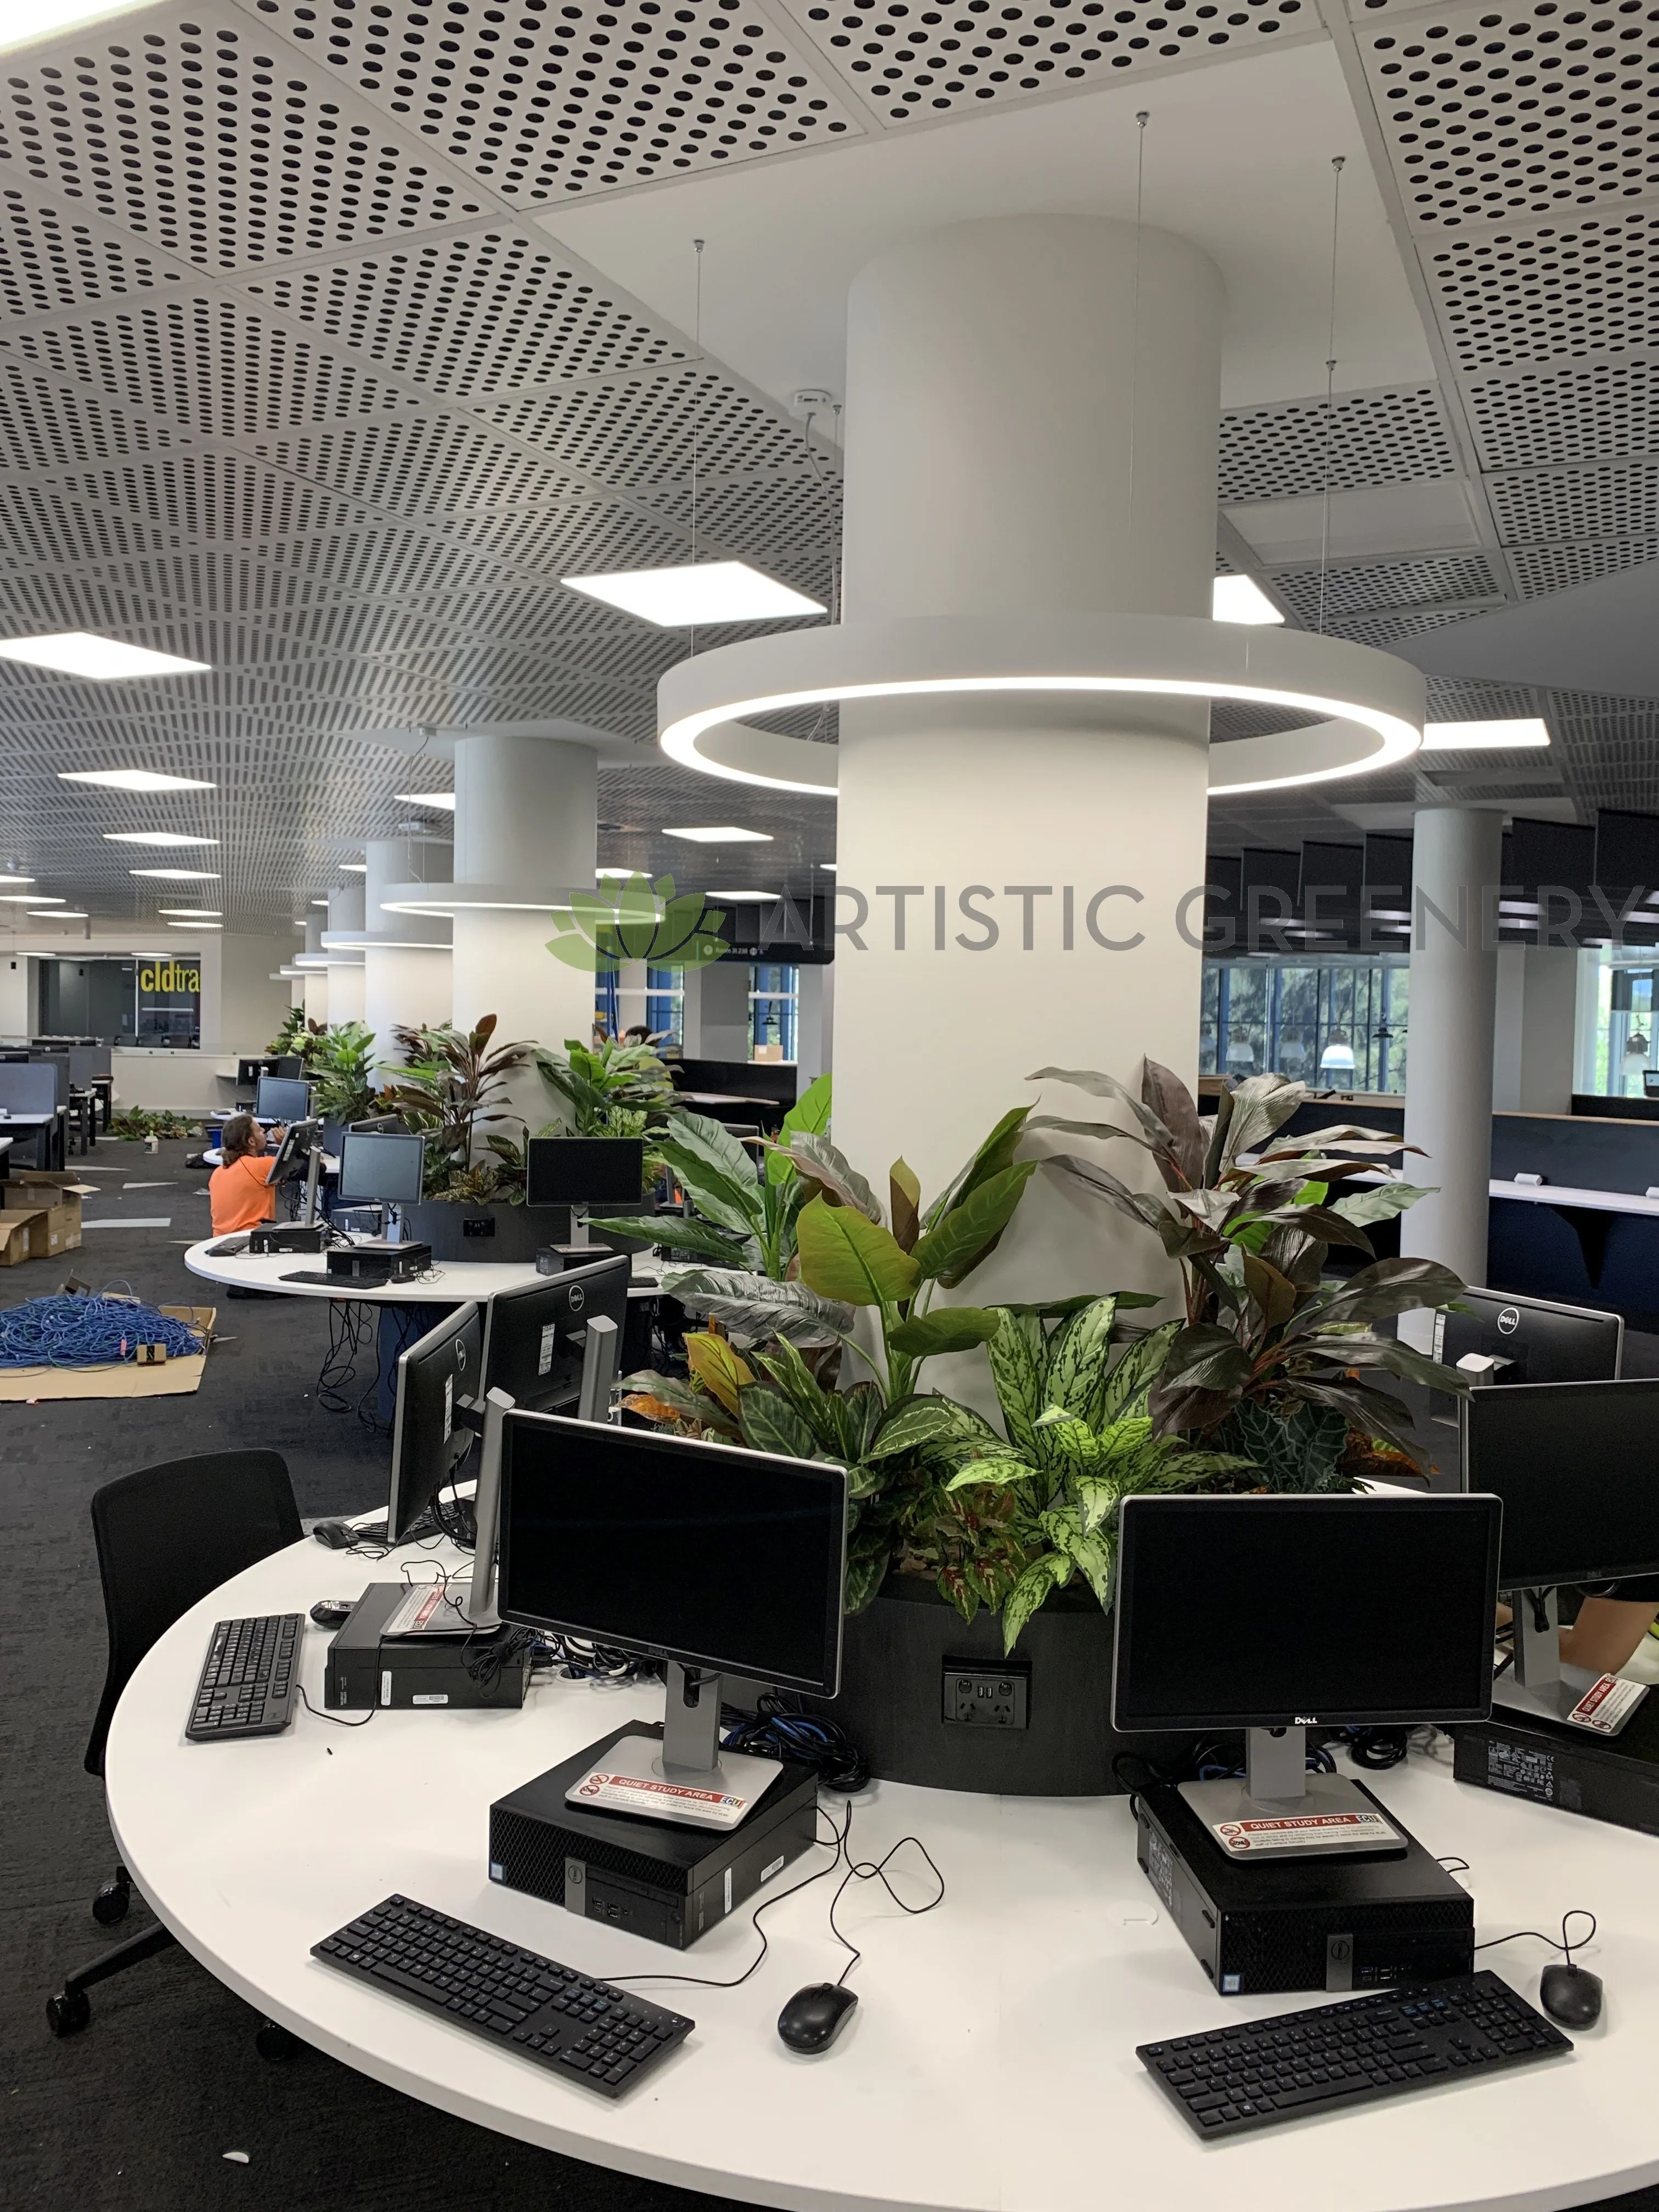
808;1575;1192;1796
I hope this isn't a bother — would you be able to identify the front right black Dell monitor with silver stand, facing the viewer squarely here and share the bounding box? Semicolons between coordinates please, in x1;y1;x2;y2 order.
1113;1496;1502;1858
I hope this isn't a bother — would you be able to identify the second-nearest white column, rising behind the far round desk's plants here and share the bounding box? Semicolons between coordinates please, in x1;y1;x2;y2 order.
454;735;600;1132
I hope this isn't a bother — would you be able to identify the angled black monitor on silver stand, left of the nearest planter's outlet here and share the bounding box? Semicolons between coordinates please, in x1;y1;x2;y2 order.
500;1411;847;1827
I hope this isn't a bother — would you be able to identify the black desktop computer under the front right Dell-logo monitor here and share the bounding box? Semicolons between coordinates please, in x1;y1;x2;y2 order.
1135;1783;1475;1997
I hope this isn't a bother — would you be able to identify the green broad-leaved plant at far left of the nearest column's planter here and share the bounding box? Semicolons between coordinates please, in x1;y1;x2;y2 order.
589;1075;838;1283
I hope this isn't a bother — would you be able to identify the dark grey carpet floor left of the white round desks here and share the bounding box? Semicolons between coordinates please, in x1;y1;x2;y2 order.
0;1144;1659;2212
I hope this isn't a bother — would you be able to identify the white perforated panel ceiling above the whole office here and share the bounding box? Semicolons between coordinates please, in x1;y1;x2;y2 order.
0;0;1659;929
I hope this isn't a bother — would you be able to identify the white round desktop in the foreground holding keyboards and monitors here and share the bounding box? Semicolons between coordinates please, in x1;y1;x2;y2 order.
106;1542;1659;2212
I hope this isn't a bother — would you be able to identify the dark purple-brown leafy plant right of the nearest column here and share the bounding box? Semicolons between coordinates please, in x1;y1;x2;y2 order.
1029;1059;1466;1491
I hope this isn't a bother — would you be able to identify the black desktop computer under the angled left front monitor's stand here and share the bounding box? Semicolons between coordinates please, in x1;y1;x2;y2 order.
489;1721;819;1951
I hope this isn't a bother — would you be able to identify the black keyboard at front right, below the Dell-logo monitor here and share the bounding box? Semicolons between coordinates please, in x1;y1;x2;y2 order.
1135;1973;1573;2137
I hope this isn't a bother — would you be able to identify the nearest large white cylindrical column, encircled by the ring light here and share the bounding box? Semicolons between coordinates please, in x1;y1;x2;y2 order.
834;215;1221;1299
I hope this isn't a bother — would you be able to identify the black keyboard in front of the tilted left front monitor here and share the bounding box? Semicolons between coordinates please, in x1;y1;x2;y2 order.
312;1898;697;2097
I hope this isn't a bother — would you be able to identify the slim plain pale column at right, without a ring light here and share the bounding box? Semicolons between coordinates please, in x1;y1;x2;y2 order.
1400;808;1504;1291
